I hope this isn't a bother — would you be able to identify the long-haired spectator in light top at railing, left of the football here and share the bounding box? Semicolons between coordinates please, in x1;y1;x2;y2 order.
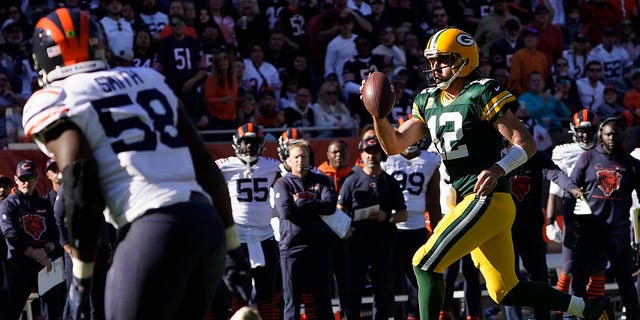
311;81;354;138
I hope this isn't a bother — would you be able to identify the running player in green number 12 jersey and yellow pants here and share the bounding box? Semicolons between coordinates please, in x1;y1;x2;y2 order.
362;29;613;320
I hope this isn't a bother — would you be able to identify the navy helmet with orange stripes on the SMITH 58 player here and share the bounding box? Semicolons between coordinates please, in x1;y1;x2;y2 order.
33;8;108;86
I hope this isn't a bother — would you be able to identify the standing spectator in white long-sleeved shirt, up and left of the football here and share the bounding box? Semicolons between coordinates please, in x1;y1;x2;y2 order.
324;14;358;85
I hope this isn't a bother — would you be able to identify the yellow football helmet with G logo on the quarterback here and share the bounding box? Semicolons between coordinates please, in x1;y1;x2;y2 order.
424;28;480;89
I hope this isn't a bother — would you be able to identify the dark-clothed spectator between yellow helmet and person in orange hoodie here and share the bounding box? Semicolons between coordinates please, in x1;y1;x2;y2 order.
488;17;522;70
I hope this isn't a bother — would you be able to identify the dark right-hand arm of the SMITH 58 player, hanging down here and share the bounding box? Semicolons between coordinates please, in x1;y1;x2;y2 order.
178;103;234;228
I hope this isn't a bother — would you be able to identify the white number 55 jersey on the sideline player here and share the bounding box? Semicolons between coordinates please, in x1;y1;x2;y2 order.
216;157;280;236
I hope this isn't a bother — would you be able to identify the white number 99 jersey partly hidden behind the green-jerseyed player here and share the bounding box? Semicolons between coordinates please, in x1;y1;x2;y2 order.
382;150;440;230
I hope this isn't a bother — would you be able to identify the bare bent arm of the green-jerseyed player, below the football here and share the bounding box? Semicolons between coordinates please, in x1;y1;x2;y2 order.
373;118;427;155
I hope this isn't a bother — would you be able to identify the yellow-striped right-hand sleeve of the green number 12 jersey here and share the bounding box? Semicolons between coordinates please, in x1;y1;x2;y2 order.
472;78;518;123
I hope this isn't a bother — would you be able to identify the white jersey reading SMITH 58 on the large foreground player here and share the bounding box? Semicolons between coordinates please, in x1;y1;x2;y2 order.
22;67;206;227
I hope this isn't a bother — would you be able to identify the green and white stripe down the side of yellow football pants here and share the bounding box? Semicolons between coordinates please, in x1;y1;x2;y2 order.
420;196;491;271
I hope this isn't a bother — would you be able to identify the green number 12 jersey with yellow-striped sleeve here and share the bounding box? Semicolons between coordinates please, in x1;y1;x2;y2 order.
412;78;517;201
